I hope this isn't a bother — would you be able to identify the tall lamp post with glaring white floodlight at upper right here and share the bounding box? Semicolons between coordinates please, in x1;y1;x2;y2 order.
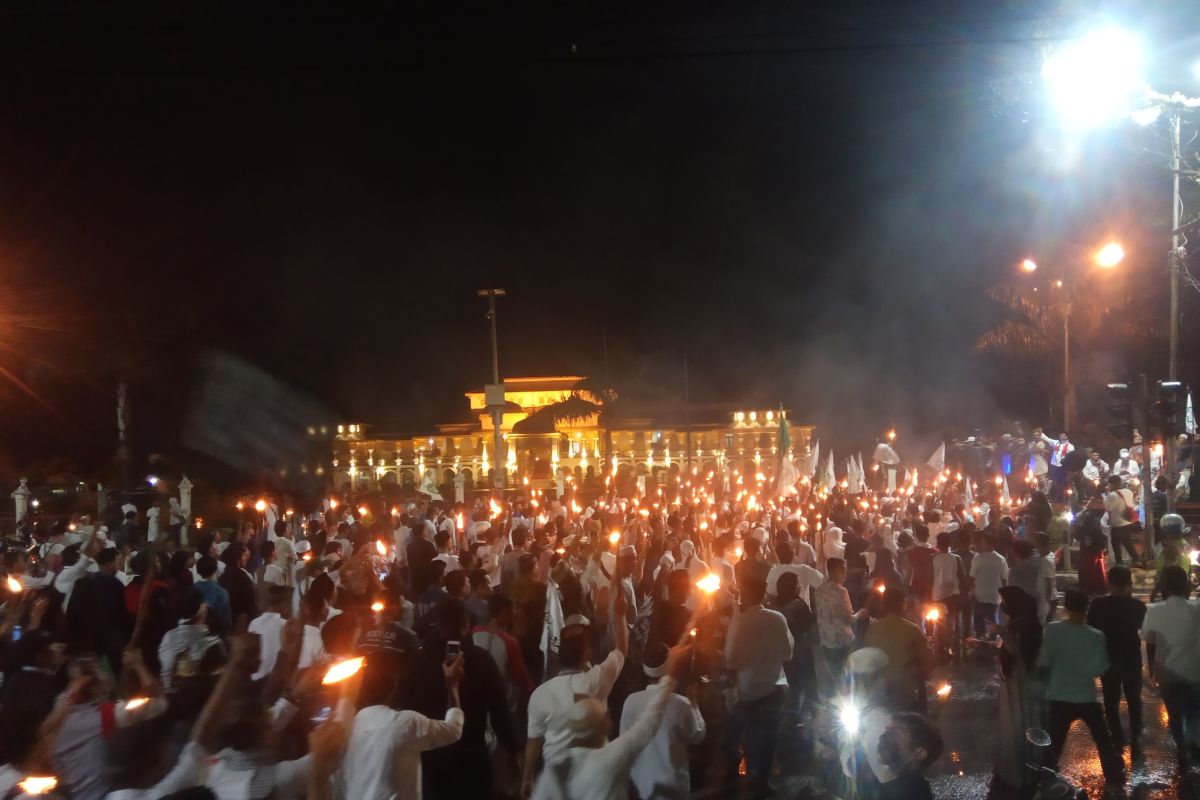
1042;28;1200;380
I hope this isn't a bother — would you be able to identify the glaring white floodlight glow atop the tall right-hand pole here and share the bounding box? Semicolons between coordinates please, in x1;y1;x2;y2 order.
1042;28;1145;131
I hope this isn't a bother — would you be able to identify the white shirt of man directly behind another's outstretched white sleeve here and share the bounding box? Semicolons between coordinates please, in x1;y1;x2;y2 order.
620;686;704;798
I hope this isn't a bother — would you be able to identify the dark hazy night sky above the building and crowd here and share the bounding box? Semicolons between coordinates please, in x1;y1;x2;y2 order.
0;1;1195;474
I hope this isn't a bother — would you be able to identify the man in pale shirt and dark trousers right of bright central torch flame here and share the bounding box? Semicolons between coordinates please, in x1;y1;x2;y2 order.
725;575;794;789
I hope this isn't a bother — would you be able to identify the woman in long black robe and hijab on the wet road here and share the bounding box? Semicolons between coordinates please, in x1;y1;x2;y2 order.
996;587;1044;789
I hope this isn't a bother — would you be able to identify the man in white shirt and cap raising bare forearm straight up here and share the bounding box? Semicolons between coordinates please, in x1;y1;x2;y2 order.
522;593;629;796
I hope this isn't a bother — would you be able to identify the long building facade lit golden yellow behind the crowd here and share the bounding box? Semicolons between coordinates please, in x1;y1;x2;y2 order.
301;375;812;495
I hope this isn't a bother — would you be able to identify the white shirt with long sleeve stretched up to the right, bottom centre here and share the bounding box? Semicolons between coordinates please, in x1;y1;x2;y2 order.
533;681;672;800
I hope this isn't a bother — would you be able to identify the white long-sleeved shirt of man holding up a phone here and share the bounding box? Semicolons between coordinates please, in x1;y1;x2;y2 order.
337;705;463;800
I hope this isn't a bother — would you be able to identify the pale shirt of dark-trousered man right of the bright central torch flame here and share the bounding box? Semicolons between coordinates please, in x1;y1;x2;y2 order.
725;606;796;702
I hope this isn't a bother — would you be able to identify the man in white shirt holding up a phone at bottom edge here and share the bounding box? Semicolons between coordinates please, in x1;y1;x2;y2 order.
337;652;464;800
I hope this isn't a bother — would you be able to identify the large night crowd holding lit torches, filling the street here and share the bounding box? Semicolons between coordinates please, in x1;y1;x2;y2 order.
0;419;1200;800
